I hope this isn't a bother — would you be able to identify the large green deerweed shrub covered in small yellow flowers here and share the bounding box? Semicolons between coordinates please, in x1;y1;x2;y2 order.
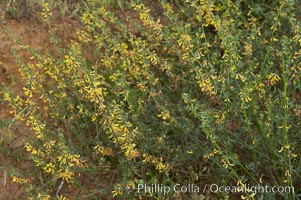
4;0;301;199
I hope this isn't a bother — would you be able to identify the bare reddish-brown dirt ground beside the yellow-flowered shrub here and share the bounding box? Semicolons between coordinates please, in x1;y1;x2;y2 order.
0;15;78;200
